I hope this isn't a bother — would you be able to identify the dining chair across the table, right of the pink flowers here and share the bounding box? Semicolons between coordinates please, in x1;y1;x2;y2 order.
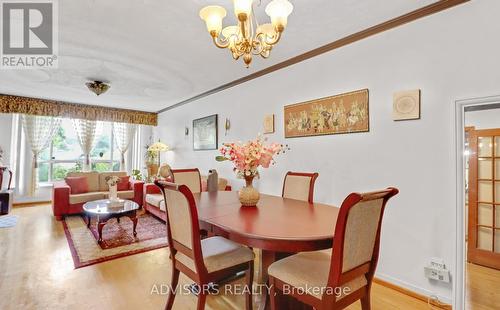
281;171;319;203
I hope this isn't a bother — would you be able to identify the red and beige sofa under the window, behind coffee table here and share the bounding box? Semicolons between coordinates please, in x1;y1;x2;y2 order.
52;171;144;220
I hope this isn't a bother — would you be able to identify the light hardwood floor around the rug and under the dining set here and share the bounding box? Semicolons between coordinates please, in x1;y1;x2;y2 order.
0;205;500;310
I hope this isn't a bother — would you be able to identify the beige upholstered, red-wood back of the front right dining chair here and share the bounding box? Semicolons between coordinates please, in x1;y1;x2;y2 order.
329;188;399;294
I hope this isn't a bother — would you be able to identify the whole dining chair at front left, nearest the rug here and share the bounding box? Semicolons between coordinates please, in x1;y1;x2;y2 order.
155;180;254;310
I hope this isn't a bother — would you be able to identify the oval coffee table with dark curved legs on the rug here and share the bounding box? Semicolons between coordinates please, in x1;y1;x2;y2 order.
83;199;139;243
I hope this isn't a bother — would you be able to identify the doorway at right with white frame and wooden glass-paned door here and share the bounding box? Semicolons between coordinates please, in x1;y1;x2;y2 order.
454;97;500;309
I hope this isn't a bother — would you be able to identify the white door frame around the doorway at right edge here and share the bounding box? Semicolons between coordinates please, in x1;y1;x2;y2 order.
453;95;500;310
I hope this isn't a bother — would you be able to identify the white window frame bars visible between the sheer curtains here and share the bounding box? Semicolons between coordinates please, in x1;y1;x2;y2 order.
37;122;121;184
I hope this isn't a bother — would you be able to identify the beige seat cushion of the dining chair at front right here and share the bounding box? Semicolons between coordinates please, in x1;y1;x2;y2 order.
268;249;368;300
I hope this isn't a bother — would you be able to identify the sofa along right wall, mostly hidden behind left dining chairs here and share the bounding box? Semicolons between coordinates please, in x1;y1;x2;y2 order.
143;175;231;222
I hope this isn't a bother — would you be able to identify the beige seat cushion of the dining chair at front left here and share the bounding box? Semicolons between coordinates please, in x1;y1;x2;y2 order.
175;237;254;272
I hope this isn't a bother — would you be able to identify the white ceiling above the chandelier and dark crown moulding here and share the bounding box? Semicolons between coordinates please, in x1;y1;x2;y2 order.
0;0;436;111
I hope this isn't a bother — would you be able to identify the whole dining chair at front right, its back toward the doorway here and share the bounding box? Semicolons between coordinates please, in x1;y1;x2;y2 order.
268;187;399;310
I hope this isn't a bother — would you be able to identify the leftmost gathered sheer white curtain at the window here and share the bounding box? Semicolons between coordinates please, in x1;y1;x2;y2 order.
21;115;61;196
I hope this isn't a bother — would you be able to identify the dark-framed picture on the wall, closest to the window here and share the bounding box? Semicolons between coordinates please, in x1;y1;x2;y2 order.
193;114;218;151
